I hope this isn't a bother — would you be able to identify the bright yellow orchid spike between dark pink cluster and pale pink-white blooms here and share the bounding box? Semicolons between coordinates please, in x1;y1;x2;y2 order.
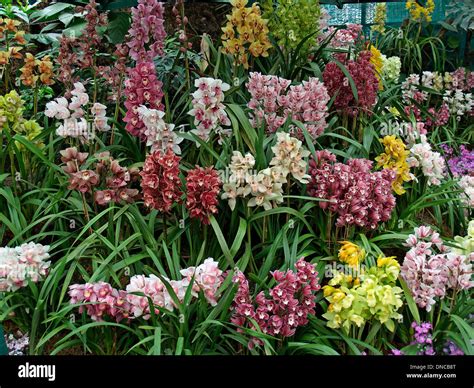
375;135;412;195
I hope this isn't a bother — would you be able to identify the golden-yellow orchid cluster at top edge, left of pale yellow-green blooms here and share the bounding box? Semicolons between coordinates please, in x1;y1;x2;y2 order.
222;0;272;69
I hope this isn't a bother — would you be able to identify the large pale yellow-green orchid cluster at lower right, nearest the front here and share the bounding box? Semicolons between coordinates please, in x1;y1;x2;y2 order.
323;256;403;333
